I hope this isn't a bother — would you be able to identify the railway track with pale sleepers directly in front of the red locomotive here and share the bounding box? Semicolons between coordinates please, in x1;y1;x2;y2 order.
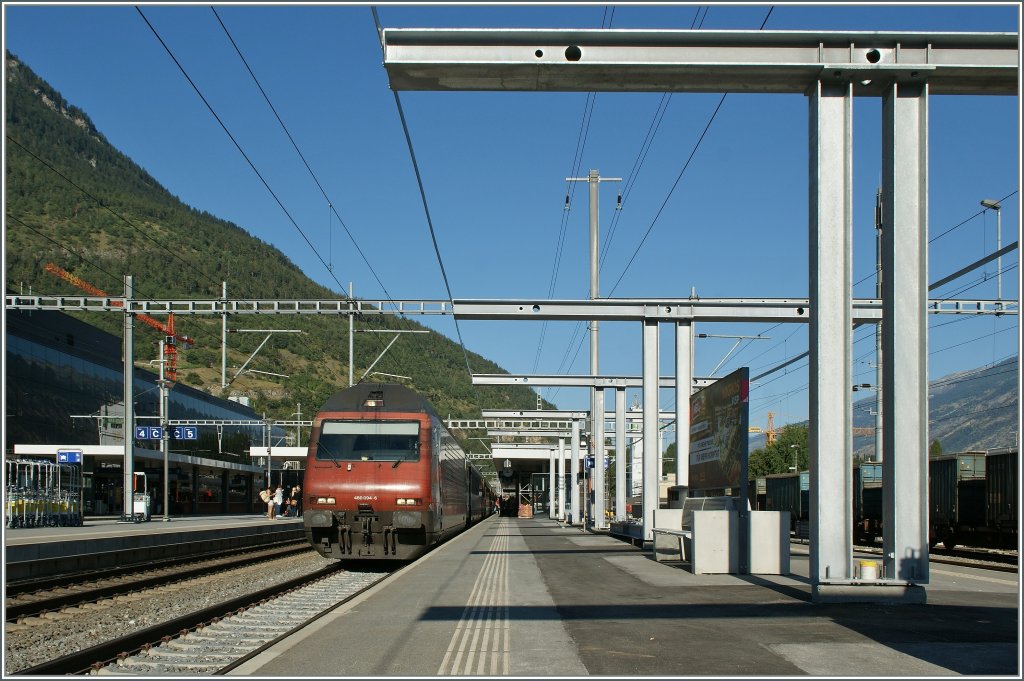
18;564;390;676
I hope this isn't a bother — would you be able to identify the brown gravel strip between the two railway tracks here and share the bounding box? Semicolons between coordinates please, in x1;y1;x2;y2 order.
4;550;335;677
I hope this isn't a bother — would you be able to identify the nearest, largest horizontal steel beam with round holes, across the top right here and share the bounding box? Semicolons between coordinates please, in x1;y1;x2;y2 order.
381;29;1019;96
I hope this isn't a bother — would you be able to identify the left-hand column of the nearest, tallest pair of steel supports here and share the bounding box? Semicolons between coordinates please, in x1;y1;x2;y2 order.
808;81;853;597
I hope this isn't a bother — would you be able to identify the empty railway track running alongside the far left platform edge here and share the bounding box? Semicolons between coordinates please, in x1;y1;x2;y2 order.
4;541;309;623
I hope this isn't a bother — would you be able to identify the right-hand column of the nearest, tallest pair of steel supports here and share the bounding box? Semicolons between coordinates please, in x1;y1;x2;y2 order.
882;83;929;584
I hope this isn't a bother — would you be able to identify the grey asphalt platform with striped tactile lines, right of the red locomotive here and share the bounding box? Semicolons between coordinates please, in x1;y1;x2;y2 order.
237;517;1020;678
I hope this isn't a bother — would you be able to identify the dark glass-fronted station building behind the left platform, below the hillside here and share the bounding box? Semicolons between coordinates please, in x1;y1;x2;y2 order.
4;310;284;515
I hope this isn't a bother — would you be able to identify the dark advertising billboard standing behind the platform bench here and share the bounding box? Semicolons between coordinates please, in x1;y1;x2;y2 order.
690;367;750;493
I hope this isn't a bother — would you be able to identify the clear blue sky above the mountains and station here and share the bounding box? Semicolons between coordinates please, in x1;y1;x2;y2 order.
4;3;1020;436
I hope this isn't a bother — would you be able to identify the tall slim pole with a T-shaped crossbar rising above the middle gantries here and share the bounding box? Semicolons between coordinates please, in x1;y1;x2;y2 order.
565;170;618;527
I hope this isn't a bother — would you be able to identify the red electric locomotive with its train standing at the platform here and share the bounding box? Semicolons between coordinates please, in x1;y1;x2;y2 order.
303;383;495;560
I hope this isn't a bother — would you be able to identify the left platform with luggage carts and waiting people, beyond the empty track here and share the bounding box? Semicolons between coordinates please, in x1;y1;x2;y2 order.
3;513;304;581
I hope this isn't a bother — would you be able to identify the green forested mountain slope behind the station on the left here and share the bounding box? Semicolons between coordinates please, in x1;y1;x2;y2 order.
5;52;550;426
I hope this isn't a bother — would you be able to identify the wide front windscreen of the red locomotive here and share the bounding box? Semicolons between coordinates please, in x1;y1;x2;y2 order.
316;421;420;465
